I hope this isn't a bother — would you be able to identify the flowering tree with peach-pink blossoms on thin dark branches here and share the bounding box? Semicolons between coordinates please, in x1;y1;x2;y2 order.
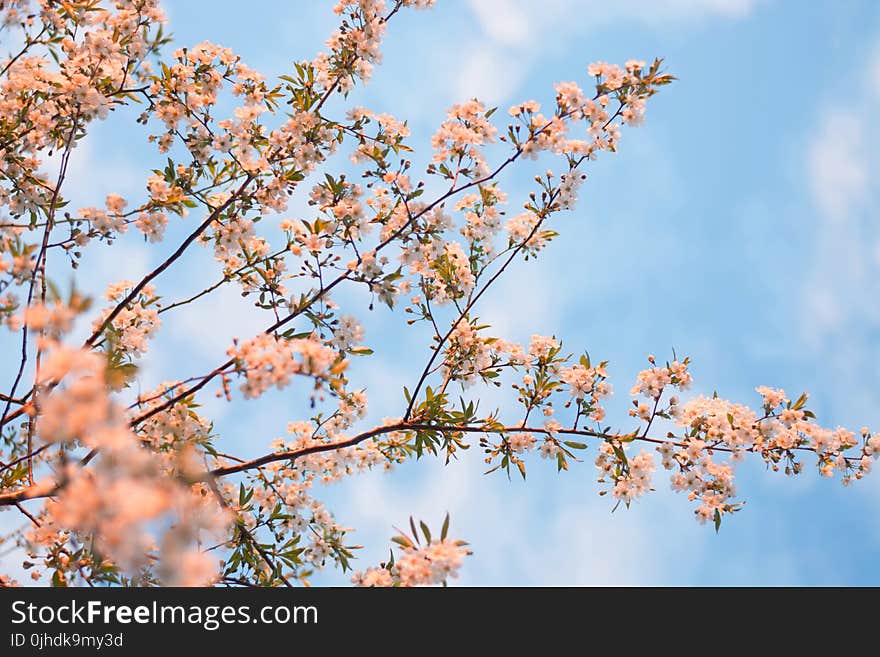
0;0;868;586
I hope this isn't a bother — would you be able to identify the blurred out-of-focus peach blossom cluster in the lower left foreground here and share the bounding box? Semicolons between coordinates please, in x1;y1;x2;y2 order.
28;344;228;585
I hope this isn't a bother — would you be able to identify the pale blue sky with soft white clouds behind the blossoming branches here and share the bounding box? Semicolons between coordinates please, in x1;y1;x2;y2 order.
0;0;880;585
